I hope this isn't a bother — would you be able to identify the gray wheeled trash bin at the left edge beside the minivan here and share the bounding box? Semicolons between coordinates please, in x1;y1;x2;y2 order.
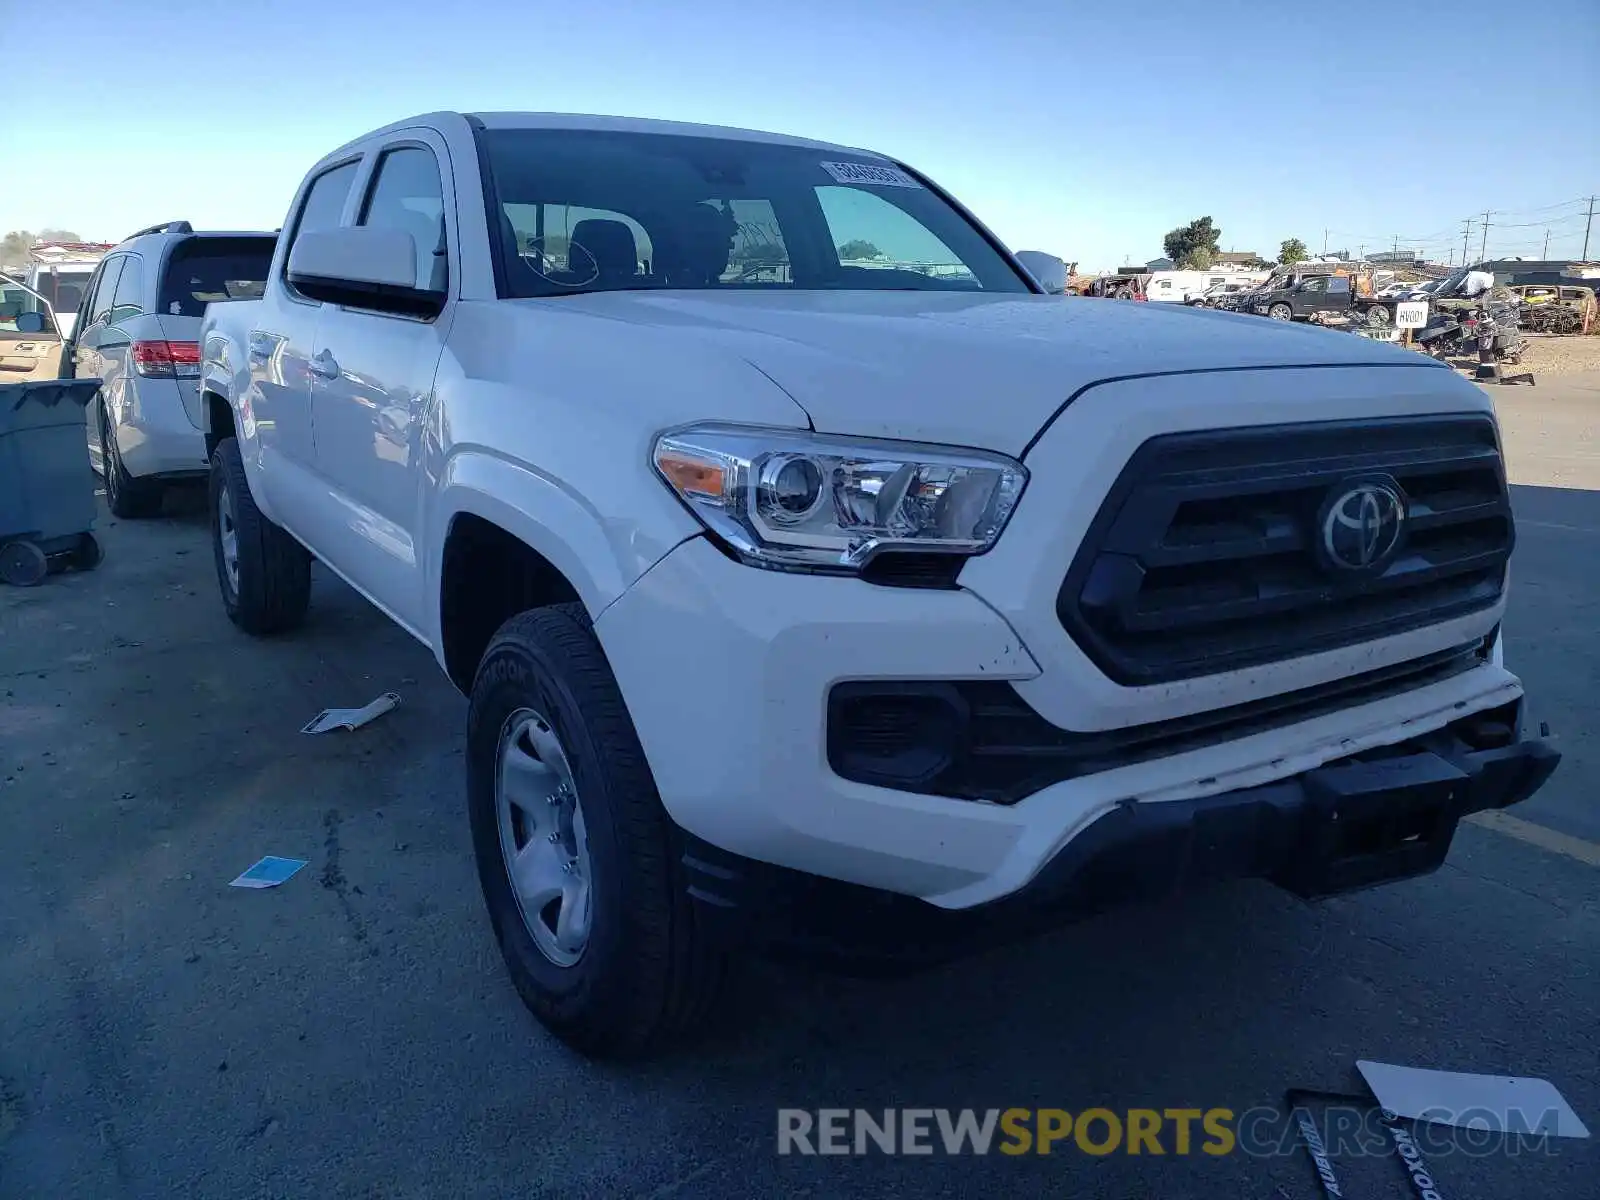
0;379;101;587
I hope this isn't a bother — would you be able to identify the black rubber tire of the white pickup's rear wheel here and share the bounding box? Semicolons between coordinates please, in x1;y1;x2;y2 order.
210;437;310;637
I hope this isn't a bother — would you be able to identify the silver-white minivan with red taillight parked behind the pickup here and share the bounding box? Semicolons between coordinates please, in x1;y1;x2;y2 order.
61;221;277;517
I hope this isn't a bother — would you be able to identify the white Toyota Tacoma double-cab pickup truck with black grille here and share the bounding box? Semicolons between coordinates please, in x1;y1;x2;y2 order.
202;114;1558;1054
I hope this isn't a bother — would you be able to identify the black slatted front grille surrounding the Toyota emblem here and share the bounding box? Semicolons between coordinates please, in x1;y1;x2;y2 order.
1056;414;1515;686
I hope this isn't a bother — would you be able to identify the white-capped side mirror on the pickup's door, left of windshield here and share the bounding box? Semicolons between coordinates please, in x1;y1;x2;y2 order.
288;226;445;317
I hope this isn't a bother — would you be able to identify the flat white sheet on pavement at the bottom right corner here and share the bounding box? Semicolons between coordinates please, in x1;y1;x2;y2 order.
1355;1061;1589;1138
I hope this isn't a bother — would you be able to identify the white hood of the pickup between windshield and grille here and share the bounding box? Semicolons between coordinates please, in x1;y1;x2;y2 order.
533;291;1429;454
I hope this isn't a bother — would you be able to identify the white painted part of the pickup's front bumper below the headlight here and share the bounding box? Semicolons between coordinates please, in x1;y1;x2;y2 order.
595;538;1542;909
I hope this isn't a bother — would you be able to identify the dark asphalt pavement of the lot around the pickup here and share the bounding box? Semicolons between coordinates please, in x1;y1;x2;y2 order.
0;376;1600;1200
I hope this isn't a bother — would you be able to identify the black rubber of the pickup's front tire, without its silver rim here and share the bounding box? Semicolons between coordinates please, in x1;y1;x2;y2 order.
467;605;726;1058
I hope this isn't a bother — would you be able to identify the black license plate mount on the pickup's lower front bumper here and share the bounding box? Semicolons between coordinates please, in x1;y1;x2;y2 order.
1277;754;1469;896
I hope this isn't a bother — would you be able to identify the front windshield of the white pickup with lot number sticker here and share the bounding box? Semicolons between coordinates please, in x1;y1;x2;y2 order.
478;130;1029;296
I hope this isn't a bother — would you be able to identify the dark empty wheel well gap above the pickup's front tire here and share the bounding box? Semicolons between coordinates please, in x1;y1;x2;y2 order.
438;512;579;694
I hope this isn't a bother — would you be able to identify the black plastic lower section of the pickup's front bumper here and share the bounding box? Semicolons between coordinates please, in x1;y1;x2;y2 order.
683;701;1560;971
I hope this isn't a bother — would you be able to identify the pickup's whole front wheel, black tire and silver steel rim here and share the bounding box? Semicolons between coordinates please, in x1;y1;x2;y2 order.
467;605;725;1058
